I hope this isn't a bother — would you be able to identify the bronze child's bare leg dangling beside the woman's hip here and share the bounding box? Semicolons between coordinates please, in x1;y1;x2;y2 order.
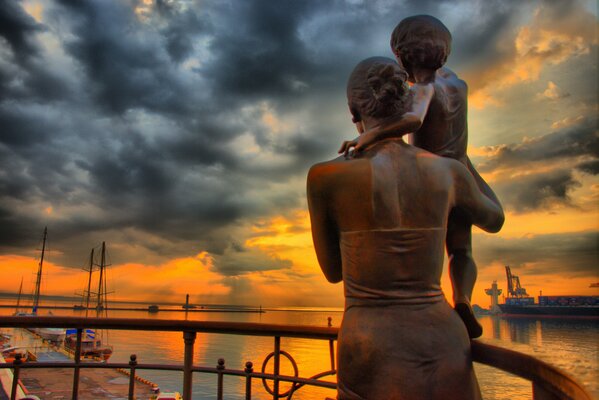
445;209;482;338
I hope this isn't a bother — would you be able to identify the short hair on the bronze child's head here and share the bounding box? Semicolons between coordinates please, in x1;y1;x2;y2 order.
391;15;451;70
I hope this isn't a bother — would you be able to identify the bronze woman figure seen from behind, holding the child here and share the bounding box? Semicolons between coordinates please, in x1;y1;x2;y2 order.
308;57;504;400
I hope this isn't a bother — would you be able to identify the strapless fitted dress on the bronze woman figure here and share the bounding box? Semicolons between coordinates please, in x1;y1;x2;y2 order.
337;228;481;400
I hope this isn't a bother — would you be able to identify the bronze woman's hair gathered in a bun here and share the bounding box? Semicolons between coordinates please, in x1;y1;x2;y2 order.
347;57;412;123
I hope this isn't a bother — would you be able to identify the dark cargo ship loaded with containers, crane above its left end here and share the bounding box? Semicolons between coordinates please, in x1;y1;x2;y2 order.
498;266;599;318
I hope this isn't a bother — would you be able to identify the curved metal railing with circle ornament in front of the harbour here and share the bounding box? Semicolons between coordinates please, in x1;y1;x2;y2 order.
0;316;592;400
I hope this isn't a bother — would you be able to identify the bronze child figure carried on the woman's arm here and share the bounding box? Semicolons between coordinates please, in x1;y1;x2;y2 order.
340;15;501;338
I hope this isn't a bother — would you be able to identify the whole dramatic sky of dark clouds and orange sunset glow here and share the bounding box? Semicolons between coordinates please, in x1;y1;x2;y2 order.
0;0;599;306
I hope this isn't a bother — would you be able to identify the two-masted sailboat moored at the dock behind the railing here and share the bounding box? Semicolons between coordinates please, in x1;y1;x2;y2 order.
64;242;113;361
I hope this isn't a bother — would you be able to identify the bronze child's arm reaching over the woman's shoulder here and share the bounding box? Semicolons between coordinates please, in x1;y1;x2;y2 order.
339;83;435;156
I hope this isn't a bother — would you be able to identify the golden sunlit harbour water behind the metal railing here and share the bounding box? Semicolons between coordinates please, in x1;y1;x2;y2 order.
0;304;599;400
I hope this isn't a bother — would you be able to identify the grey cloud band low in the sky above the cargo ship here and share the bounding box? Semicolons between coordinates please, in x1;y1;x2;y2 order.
474;231;599;277
